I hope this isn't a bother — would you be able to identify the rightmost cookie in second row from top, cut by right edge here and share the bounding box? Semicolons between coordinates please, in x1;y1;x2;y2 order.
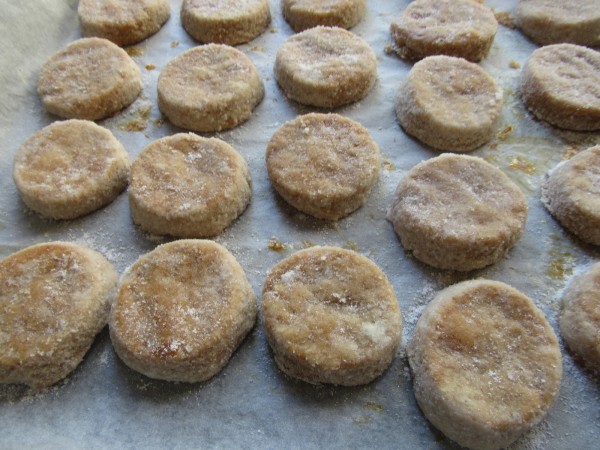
521;44;600;131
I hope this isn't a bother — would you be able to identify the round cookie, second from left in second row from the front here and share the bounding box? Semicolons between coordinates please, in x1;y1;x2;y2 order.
129;133;252;238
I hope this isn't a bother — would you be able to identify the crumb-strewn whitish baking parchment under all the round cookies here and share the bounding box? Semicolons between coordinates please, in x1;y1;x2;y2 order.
0;0;600;449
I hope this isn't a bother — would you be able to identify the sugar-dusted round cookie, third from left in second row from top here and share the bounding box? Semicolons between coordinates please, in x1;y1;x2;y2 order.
275;27;377;108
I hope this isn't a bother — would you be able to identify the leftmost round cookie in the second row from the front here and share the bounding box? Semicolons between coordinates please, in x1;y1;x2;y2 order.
13;119;129;219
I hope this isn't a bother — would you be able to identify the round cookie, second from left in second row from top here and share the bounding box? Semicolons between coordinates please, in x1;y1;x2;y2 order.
158;44;265;132
